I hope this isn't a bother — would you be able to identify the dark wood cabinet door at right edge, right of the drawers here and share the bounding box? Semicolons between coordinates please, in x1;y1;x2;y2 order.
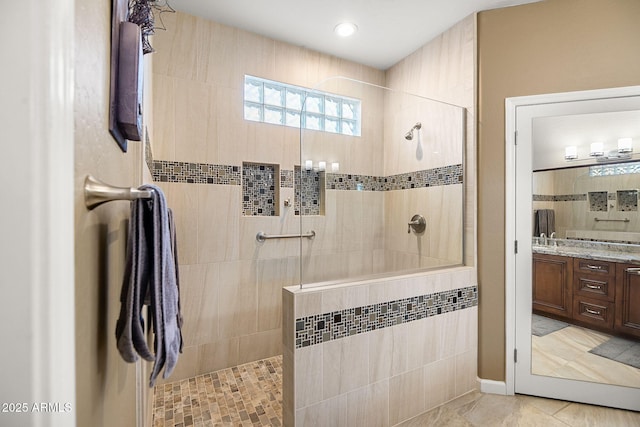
615;264;640;337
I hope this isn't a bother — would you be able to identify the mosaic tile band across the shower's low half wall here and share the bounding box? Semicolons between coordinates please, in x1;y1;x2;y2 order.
295;286;478;348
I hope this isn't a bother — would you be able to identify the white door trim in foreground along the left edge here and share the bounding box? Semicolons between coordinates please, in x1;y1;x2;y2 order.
0;0;76;426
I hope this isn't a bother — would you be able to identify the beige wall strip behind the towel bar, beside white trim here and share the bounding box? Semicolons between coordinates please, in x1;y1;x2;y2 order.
74;0;148;427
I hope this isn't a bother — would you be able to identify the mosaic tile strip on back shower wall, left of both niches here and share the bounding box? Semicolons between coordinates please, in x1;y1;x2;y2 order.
151;160;242;185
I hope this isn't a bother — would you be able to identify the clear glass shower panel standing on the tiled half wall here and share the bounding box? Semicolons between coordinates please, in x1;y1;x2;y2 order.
294;77;466;288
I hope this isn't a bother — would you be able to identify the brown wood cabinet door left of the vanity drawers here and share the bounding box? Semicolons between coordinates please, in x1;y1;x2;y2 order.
532;254;573;319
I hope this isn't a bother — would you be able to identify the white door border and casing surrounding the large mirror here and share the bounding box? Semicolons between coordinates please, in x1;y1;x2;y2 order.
506;87;640;410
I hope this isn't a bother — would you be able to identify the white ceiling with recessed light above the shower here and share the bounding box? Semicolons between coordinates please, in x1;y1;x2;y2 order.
169;0;538;70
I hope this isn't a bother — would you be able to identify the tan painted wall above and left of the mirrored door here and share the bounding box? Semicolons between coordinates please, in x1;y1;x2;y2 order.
478;0;640;381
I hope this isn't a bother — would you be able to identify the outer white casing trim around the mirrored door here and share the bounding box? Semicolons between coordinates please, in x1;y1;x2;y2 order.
505;86;640;406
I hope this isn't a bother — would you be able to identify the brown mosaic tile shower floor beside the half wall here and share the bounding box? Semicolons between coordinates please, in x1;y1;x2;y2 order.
153;356;282;427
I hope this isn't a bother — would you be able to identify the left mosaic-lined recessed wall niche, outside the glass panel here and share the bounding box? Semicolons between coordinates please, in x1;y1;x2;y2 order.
242;163;280;216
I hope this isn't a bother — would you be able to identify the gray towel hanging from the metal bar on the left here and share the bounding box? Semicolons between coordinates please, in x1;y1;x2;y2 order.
116;185;182;387
